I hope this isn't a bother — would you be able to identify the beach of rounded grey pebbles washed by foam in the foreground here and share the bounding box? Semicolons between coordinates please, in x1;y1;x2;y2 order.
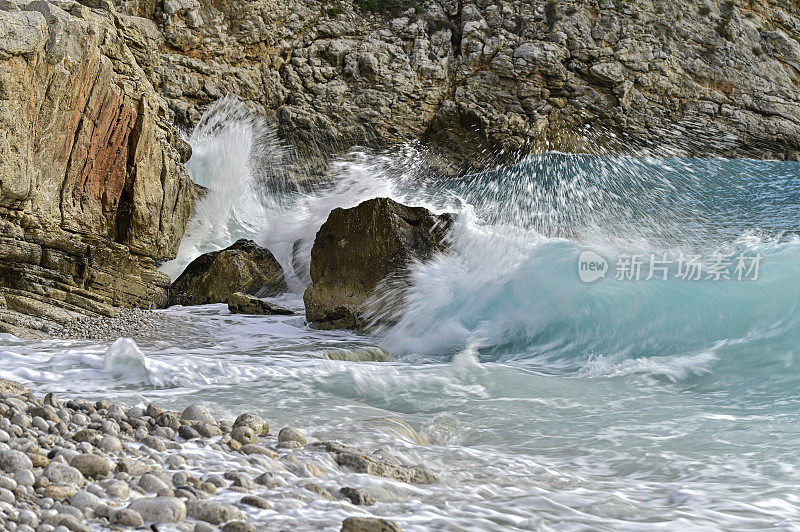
0;380;424;532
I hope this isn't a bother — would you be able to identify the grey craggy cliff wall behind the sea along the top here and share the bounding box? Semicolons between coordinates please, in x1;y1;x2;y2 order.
116;0;800;160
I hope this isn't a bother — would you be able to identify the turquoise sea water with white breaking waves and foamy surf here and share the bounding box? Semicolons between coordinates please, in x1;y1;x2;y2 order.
0;102;800;531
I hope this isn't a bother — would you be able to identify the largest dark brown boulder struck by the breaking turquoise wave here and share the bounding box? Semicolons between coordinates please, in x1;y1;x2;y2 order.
303;198;453;329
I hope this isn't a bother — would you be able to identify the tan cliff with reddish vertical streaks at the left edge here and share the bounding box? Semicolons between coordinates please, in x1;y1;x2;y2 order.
0;0;192;334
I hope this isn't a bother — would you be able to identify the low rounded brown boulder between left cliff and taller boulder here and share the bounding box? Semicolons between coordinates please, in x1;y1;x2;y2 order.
170;239;287;305
